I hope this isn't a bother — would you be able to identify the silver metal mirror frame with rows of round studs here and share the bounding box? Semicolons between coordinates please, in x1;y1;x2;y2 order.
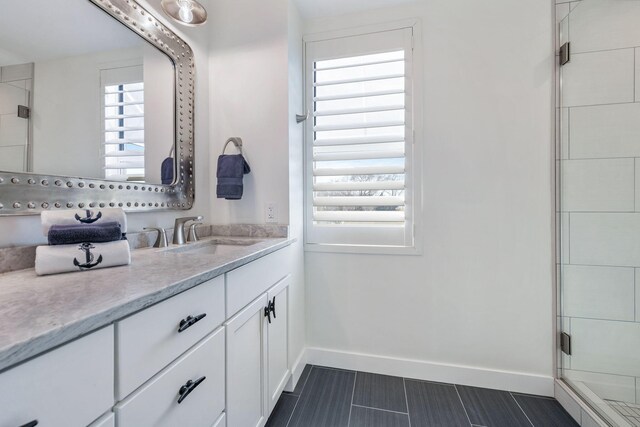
0;0;195;216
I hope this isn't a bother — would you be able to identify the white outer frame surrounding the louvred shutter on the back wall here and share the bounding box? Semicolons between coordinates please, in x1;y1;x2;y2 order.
303;19;424;255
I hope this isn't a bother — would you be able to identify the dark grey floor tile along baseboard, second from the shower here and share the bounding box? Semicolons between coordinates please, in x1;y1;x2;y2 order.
456;386;531;427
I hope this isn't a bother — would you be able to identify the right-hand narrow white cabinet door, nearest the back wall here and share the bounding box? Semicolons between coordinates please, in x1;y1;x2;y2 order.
267;276;291;412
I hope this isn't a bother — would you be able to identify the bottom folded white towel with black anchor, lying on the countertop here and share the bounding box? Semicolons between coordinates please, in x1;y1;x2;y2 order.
36;240;131;276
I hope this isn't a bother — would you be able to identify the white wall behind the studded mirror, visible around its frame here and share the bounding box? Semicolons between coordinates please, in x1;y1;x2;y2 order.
0;0;211;247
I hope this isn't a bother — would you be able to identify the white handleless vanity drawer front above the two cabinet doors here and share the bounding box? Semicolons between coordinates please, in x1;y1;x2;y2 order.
227;247;291;318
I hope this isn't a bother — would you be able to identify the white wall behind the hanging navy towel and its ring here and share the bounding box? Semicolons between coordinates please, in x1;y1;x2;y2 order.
209;0;289;224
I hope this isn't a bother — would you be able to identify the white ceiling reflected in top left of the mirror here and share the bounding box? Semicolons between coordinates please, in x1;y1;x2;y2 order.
0;0;142;66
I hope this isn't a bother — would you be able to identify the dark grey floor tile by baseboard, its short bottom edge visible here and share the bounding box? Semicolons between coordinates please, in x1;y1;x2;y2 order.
353;372;407;412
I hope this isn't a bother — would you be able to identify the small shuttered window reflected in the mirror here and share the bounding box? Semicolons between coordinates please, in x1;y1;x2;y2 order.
101;66;145;182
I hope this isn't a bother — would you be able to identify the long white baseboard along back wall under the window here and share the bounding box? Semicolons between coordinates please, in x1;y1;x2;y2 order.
306;348;554;396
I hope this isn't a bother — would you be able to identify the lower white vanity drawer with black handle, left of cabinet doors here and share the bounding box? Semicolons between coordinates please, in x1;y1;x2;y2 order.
115;328;225;427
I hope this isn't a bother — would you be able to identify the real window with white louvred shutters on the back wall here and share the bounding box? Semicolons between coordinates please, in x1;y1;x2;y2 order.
305;27;418;254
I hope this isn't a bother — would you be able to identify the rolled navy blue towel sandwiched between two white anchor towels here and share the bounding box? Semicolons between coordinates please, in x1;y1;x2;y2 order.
48;222;126;245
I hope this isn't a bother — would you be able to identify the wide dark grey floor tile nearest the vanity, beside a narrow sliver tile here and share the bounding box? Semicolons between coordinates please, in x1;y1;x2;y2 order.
289;366;356;427
